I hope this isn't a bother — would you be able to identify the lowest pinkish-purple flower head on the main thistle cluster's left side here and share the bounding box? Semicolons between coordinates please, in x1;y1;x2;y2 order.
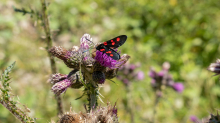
51;79;72;95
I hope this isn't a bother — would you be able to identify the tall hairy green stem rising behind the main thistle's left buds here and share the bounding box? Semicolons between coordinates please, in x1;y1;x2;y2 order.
41;0;63;115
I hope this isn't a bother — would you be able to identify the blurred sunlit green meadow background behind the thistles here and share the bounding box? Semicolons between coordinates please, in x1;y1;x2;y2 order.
0;0;220;123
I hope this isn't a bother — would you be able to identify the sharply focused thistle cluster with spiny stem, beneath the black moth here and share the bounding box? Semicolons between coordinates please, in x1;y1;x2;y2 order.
49;34;129;112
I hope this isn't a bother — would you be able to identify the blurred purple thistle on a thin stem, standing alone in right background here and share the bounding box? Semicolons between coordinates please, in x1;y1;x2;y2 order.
149;62;184;123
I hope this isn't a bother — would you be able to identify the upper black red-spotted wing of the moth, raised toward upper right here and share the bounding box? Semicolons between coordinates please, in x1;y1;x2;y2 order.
103;35;127;49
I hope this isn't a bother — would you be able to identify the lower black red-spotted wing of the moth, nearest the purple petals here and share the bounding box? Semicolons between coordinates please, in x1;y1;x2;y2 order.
96;44;120;60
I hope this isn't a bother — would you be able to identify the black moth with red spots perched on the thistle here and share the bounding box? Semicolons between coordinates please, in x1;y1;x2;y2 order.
96;35;127;60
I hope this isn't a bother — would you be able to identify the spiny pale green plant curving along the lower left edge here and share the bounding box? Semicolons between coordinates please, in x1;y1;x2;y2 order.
0;62;35;123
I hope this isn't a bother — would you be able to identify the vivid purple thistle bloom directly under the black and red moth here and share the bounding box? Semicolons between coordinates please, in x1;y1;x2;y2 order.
95;50;124;69
